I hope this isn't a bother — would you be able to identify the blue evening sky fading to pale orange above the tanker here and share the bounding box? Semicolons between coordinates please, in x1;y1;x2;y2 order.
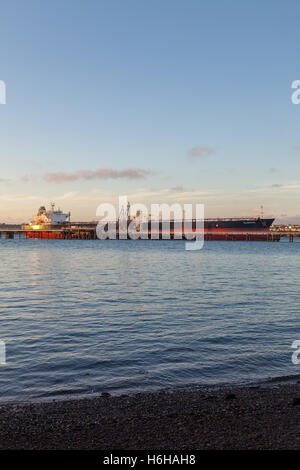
0;0;300;223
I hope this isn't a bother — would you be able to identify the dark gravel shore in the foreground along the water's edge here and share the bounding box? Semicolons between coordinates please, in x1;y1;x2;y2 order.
0;384;300;450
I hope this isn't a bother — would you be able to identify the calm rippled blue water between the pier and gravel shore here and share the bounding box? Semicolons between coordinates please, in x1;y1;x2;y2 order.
0;238;300;401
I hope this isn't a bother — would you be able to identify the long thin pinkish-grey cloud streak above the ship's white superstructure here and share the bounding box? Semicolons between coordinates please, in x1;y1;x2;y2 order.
43;168;153;183
